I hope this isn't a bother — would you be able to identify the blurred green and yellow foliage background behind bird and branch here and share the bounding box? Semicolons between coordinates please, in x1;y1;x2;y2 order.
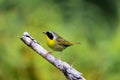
0;0;120;80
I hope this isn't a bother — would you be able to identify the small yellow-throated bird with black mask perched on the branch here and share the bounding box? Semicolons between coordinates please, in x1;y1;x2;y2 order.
43;31;79;52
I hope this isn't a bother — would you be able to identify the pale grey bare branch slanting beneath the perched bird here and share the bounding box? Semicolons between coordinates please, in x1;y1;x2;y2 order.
21;32;85;80
